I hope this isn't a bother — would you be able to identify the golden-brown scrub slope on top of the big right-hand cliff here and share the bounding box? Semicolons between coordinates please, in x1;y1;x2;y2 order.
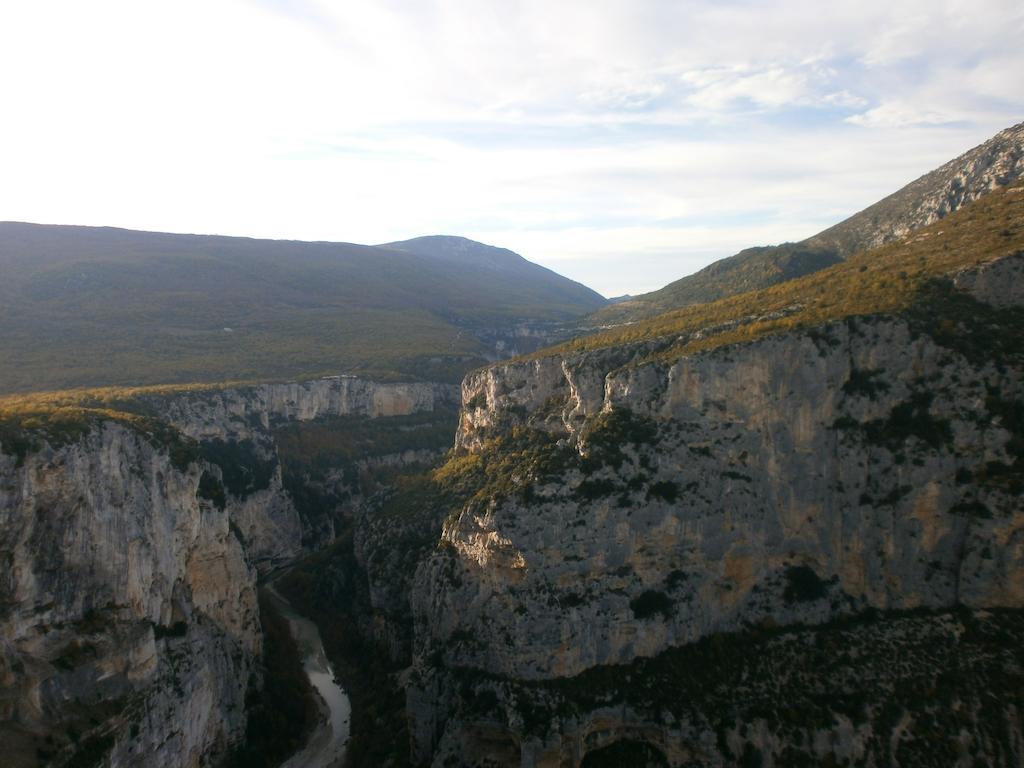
525;183;1024;368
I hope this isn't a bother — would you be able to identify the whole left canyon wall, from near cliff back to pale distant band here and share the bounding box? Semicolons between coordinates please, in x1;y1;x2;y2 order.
0;377;457;766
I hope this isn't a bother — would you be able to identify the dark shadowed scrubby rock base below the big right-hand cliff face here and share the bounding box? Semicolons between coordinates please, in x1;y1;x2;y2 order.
410;609;1024;768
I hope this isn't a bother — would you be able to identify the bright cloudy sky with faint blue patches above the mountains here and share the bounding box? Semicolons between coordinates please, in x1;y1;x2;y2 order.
0;0;1024;296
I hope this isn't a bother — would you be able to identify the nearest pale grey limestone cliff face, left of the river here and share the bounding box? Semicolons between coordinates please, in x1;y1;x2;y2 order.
0;422;260;766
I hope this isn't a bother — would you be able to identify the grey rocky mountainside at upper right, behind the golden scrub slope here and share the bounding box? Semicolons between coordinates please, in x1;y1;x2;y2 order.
587;123;1024;326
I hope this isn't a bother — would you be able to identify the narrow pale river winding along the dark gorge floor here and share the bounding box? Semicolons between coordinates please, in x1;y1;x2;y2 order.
266;584;352;768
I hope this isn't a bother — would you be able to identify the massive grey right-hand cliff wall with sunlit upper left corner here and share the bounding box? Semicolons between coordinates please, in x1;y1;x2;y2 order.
410;250;1024;765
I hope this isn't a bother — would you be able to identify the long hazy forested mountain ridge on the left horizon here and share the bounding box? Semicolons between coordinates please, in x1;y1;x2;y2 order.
0;222;605;392
